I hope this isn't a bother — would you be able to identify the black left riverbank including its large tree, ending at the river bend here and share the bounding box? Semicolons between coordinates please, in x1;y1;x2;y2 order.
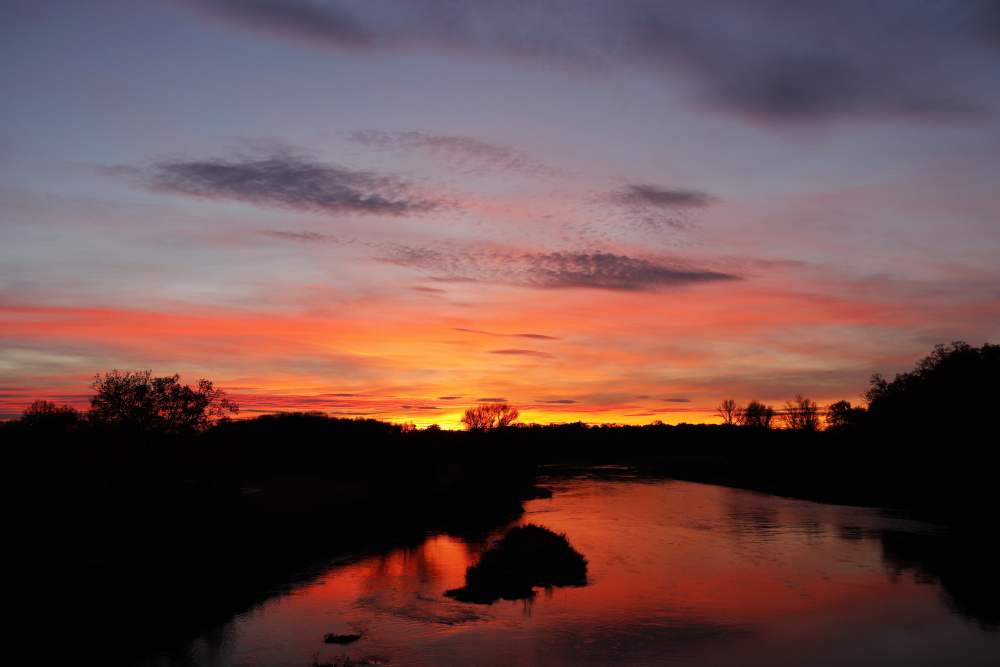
0;373;534;665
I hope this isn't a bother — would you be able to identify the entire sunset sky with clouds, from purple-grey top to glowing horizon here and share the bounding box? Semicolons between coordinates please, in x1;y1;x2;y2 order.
0;0;1000;428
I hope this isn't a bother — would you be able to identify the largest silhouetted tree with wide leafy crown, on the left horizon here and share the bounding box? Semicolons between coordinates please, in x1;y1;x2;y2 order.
88;369;239;434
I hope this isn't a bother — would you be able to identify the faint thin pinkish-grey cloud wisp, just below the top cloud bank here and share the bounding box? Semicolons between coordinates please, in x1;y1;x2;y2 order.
350;130;559;176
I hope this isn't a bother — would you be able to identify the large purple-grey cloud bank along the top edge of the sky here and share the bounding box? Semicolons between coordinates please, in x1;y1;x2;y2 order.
178;0;1000;121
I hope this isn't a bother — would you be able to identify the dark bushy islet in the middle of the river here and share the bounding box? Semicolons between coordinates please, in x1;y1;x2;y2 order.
445;523;587;604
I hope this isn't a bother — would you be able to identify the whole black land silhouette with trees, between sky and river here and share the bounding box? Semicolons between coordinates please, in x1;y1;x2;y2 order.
7;343;1000;664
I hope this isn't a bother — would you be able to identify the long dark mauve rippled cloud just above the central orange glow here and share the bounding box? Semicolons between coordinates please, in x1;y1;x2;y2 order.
383;246;738;291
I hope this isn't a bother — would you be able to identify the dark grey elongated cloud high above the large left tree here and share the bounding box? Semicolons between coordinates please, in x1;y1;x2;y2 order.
111;150;443;215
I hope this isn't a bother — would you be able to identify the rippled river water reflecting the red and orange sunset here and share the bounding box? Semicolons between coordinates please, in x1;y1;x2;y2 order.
146;474;1000;667
